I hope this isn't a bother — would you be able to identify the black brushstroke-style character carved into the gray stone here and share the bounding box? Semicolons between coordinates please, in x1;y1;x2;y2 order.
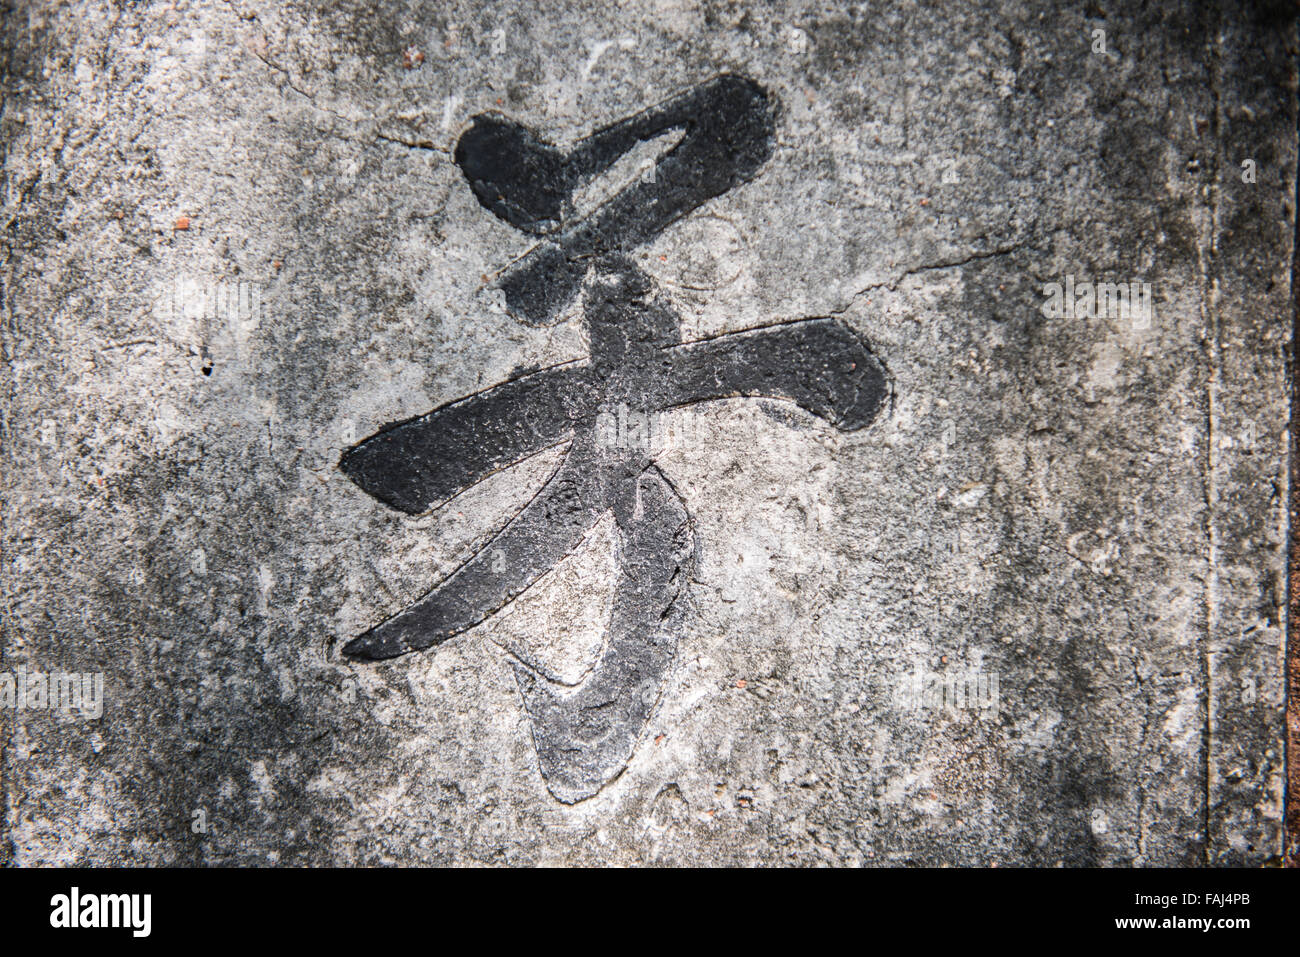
341;75;888;804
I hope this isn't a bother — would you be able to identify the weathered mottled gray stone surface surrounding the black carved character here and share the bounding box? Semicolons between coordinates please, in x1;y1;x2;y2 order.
0;0;1296;865
